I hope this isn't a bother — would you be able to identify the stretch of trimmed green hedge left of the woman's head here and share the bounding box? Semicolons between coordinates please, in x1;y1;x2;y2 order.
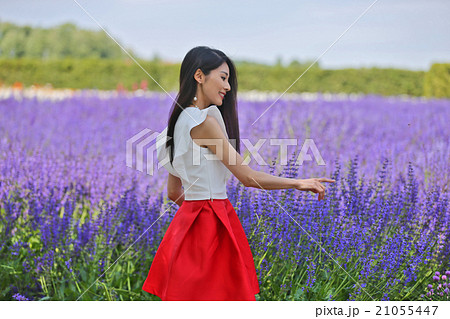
0;58;179;91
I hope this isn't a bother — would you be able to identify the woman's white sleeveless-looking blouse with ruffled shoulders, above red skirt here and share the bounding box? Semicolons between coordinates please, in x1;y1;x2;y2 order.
156;105;232;200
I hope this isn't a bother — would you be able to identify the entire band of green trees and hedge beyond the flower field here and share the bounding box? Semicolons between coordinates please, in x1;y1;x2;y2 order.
0;22;450;97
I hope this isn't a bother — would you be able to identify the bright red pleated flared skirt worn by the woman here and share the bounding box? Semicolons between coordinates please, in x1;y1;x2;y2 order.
142;198;259;300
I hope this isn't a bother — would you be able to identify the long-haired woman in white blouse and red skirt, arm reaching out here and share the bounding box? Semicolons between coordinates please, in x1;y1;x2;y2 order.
142;46;334;300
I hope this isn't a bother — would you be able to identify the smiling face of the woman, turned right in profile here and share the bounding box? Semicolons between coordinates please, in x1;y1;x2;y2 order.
202;62;231;105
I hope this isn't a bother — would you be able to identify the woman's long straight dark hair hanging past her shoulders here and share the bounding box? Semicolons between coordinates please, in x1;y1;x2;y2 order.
166;46;241;164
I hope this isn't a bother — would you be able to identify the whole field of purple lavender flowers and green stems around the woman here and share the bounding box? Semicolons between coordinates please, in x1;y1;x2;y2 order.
0;91;450;300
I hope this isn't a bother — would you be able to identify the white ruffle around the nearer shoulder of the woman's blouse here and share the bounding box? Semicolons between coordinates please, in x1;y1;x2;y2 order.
173;105;228;182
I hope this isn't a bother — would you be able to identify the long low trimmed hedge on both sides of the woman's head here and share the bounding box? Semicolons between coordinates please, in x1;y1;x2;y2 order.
0;57;432;96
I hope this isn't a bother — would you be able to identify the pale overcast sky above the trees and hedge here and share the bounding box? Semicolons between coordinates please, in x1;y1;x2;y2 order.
0;0;450;70
